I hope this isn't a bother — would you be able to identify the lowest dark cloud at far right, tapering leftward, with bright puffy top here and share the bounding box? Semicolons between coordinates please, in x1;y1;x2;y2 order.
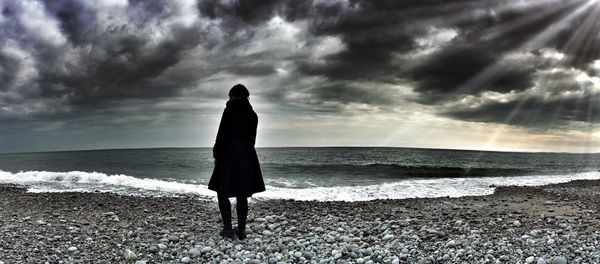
443;70;600;128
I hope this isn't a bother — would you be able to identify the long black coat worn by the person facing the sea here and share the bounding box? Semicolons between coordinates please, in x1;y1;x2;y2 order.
208;99;265;197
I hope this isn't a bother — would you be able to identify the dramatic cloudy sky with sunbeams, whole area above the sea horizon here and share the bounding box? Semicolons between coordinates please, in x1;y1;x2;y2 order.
0;0;600;152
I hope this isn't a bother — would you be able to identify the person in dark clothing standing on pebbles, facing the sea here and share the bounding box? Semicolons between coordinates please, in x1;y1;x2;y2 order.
208;84;265;239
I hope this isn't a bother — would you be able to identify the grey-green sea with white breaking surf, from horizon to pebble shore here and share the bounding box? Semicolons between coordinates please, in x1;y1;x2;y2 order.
0;147;600;201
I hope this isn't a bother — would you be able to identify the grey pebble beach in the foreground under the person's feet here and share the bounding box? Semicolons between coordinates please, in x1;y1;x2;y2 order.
0;181;600;264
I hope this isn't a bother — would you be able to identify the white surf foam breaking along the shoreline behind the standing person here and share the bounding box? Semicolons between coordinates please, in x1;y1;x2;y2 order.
0;170;600;201
